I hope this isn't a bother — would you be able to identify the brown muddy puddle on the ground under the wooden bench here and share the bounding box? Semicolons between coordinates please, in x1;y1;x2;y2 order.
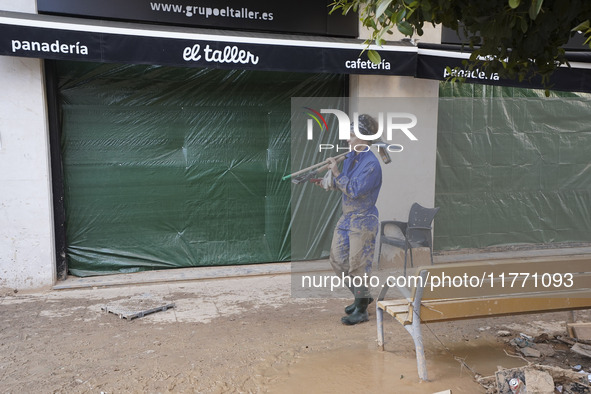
263;341;524;394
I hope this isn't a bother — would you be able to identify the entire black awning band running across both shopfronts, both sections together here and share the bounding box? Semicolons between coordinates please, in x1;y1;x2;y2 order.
8;11;591;92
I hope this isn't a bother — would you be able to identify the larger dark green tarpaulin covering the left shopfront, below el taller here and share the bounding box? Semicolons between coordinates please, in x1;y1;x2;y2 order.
58;62;346;276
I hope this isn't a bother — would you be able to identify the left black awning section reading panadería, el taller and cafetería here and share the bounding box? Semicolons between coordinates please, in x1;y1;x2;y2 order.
0;12;416;76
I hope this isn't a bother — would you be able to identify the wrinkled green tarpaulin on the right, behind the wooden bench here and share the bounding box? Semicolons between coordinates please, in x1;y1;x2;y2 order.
434;83;591;249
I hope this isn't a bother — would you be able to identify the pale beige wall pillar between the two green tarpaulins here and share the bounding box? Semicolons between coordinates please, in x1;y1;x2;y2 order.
351;75;439;221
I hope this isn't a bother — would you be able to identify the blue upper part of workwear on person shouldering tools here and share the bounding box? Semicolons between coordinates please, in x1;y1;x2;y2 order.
335;151;382;230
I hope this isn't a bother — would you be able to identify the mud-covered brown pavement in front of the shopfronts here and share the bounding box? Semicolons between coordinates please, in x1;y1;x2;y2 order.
0;275;590;394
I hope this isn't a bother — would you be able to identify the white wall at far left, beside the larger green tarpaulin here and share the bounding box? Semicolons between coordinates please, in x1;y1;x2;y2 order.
0;0;56;290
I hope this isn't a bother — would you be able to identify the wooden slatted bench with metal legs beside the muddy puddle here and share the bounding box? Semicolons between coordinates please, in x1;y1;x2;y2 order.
376;255;591;380
